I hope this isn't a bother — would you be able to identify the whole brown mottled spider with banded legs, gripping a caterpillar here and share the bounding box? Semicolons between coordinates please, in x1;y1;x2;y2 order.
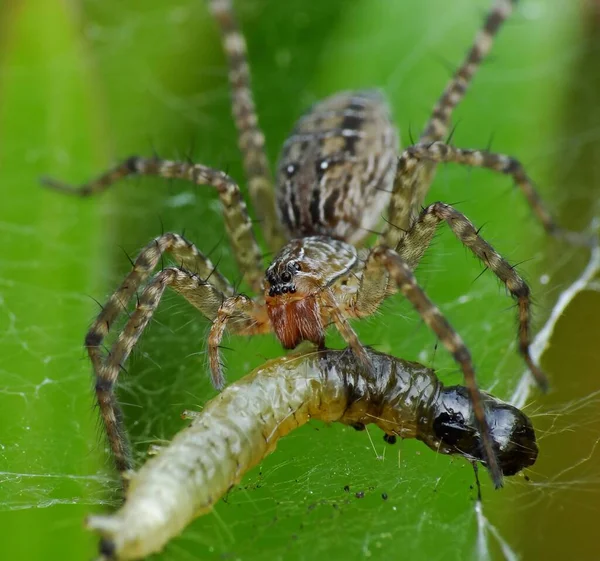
46;0;576;486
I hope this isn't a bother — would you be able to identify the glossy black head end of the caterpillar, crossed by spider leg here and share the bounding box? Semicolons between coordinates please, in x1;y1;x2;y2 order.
427;386;538;475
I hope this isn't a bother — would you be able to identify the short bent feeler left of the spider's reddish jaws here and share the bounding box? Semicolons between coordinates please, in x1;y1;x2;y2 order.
208;294;271;390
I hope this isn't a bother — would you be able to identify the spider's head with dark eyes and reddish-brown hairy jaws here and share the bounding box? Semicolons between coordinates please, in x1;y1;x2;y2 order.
264;236;357;349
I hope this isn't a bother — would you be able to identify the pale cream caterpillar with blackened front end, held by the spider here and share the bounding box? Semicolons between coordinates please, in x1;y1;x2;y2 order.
86;349;537;561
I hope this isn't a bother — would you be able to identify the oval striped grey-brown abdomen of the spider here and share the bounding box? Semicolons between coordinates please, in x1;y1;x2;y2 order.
277;90;399;243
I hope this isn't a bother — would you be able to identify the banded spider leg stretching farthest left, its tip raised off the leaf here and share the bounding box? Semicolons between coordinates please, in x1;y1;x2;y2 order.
42;160;263;292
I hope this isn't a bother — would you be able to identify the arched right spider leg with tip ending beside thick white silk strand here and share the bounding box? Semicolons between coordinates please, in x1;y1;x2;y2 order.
397;202;548;390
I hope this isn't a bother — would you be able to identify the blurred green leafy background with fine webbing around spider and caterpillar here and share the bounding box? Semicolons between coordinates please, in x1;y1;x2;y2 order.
0;0;600;560
